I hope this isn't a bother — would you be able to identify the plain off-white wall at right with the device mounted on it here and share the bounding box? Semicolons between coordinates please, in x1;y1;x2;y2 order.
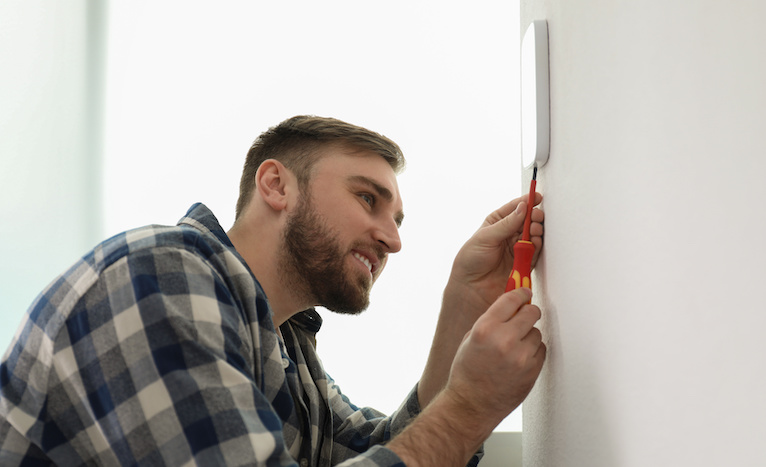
521;0;766;467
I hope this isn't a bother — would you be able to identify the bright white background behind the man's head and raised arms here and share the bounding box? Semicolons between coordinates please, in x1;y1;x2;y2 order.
0;0;521;430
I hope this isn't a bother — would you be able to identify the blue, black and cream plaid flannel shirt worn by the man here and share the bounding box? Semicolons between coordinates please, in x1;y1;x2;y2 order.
0;204;426;466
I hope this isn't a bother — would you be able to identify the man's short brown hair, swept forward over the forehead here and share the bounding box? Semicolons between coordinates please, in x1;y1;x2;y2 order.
235;115;405;219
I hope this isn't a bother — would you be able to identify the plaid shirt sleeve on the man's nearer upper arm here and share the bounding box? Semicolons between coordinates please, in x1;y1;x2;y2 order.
43;248;297;466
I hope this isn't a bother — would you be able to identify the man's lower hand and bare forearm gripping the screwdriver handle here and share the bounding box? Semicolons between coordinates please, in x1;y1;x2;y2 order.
388;288;547;466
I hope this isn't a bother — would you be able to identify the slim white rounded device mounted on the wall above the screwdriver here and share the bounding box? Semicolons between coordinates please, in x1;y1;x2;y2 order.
521;20;550;169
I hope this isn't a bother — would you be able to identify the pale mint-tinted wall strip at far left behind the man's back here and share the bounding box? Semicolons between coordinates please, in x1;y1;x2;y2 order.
0;0;103;348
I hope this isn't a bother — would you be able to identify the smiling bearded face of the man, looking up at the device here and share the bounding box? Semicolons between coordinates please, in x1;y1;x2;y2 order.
282;147;403;313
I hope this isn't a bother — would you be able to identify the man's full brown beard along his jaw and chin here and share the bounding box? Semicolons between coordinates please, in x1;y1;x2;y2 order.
279;192;377;314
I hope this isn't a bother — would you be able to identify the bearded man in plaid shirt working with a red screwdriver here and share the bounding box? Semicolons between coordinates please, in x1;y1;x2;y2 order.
0;117;545;466
